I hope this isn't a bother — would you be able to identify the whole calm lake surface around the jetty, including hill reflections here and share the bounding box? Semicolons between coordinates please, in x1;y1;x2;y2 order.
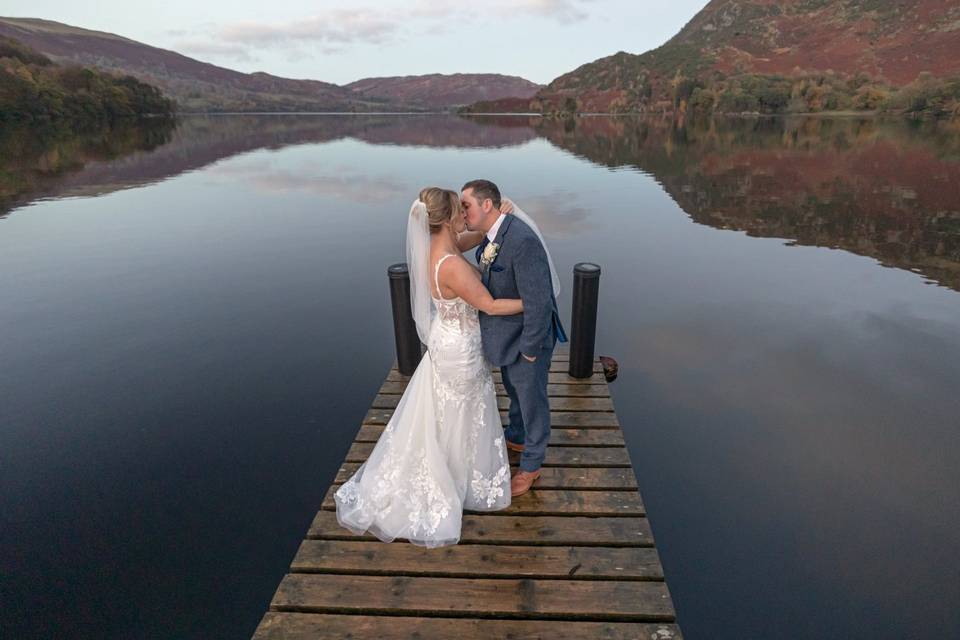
0;115;960;640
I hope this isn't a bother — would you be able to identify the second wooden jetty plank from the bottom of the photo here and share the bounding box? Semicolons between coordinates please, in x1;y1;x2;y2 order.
270;573;675;622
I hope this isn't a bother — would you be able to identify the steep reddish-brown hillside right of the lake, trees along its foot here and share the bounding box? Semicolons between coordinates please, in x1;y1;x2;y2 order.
476;0;960;112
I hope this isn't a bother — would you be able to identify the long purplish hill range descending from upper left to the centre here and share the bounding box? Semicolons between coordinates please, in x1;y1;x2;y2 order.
0;18;540;111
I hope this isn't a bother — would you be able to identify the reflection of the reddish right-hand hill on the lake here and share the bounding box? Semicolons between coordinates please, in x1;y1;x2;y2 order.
534;118;960;290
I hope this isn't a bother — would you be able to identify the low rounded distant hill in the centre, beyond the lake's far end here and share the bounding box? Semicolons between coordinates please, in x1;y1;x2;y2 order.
344;73;543;109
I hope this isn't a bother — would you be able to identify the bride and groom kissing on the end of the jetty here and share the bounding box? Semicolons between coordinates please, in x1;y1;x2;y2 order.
334;180;567;547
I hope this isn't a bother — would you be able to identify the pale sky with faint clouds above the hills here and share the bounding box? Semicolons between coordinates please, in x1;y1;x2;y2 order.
0;0;707;84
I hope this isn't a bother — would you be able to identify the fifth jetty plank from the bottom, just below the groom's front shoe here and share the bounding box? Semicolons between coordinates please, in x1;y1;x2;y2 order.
321;484;646;517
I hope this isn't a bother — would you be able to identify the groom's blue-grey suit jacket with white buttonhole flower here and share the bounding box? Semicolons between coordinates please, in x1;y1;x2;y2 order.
476;215;567;367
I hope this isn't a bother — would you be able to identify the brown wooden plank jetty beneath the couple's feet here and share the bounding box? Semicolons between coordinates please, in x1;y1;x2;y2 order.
253;345;682;640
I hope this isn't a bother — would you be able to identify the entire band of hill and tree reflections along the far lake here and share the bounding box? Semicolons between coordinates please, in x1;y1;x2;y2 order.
9;115;960;290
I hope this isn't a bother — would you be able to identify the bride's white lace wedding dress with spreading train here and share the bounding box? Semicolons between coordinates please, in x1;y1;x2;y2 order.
335;254;510;547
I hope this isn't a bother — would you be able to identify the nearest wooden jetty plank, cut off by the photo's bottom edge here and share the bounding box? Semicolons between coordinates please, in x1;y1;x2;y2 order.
253;611;683;640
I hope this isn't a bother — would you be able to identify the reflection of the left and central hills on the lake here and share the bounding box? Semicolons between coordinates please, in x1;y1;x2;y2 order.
0;115;537;218
